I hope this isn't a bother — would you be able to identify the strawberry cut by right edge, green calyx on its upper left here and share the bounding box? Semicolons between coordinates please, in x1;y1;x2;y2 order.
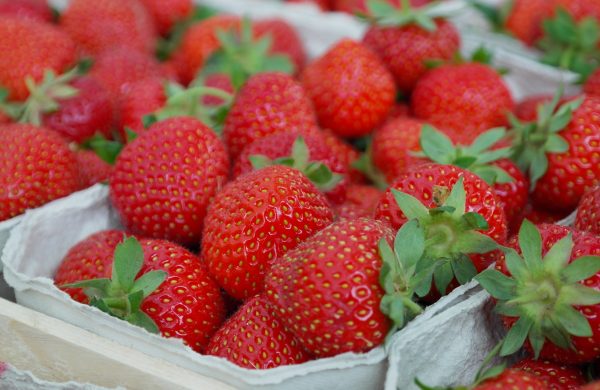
512;95;600;212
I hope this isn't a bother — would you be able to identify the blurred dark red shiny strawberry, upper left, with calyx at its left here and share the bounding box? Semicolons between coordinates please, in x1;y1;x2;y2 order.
42;77;113;143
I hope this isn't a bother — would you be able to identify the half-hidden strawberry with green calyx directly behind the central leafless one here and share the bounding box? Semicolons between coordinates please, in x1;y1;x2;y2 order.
233;132;348;204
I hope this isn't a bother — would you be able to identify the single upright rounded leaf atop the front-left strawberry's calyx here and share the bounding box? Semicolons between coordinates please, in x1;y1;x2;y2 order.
112;237;144;291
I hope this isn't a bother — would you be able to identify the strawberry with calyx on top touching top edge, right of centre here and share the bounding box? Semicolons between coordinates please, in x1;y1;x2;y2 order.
363;0;460;94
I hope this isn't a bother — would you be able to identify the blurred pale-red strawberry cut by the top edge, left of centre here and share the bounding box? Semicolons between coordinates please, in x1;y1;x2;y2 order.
60;0;156;57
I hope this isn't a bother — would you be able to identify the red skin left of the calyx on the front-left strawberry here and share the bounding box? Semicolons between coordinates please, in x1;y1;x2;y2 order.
54;230;128;304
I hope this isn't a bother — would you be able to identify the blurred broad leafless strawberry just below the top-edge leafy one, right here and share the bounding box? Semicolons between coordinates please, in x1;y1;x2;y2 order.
411;63;514;135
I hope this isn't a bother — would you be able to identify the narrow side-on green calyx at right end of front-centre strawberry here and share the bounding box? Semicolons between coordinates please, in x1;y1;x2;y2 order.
378;219;433;335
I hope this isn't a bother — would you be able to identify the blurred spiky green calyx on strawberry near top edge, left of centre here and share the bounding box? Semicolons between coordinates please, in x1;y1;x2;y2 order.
199;18;296;90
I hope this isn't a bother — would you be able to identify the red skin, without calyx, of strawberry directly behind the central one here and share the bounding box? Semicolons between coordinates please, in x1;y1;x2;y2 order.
233;132;348;204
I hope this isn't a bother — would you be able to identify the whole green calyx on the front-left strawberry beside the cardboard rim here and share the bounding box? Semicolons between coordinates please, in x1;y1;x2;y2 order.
60;237;167;333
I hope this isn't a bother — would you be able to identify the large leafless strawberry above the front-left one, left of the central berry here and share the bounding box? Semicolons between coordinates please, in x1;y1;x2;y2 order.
110;117;229;245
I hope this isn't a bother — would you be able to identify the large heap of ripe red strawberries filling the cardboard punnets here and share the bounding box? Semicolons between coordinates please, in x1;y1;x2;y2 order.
0;0;600;389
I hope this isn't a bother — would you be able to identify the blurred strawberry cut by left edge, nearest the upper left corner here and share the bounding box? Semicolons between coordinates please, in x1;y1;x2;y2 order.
0;17;76;101
